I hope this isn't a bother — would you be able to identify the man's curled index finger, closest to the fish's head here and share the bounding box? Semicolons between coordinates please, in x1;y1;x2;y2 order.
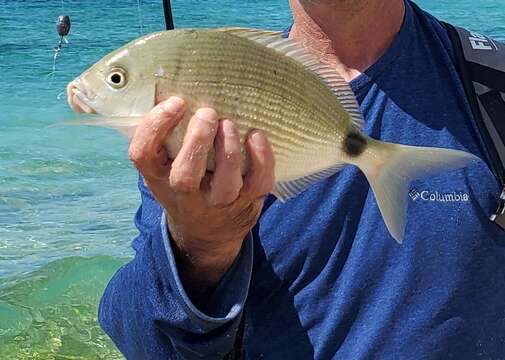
129;97;184;178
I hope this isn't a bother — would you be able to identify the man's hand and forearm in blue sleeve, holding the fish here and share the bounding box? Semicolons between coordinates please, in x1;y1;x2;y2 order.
99;98;275;359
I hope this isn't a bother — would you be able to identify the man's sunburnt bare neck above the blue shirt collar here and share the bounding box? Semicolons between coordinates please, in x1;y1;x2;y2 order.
289;0;405;81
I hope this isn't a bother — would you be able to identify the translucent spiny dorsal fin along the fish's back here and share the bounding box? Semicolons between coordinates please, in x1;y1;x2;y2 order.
219;28;364;129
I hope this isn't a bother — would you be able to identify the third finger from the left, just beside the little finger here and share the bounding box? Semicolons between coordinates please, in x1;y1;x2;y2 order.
210;120;243;206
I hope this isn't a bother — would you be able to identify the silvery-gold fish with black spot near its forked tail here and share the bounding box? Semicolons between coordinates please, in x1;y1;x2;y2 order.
67;28;479;243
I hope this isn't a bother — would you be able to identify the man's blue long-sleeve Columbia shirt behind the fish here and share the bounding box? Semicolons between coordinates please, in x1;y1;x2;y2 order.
99;1;505;360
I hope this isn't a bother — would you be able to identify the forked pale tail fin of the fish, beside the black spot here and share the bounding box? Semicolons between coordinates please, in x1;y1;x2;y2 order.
349;139;479;243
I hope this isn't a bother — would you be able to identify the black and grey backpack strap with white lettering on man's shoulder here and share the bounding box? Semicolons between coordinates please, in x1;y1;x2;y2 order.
443;23;505;229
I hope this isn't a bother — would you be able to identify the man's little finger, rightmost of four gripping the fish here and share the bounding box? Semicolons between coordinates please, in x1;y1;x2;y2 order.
242;130;275;199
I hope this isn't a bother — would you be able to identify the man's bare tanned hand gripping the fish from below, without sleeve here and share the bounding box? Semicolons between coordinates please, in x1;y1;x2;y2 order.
129;98;275;290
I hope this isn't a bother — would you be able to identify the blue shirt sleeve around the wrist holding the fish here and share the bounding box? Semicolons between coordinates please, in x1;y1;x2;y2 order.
98;179;253;359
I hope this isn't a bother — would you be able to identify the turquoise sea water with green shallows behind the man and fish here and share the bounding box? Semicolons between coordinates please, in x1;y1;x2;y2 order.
0;0;505;359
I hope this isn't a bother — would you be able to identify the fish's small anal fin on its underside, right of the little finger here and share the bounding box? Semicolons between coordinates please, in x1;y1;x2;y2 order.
272;163;345;202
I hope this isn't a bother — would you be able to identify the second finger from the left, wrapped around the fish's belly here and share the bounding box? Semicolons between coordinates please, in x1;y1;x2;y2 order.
170;108;219;192
